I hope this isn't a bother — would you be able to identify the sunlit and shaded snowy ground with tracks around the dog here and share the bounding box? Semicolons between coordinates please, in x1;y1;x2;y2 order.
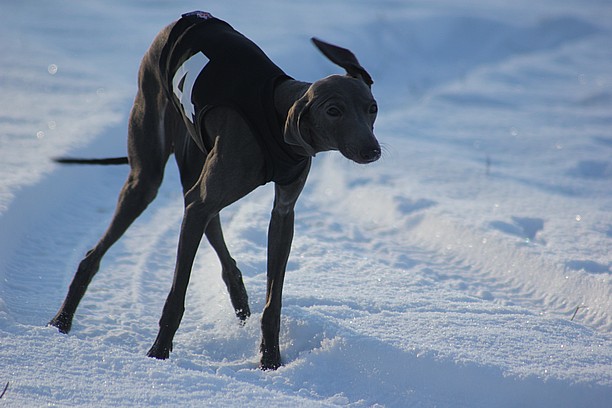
0;0;612;407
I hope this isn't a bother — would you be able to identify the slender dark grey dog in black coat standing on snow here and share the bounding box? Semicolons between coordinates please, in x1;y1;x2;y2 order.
49;12;381;370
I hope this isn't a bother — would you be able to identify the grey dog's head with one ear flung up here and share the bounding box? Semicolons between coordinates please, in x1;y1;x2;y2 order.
285;39;381;164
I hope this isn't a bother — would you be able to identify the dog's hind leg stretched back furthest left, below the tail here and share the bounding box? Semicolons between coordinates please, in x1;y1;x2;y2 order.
49;63;172;333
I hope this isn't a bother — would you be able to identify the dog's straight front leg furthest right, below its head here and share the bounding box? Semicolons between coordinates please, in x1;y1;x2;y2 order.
260;163;309;370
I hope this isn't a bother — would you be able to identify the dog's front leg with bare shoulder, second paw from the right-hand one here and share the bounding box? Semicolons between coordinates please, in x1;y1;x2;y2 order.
148;113;264;359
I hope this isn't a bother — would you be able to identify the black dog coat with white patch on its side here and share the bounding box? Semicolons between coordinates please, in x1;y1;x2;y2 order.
159;11;310;184
